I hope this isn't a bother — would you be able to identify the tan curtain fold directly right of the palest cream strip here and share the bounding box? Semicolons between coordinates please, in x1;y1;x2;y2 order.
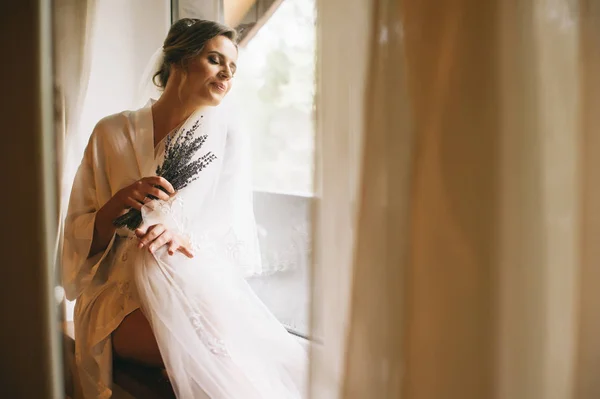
342;0;414;398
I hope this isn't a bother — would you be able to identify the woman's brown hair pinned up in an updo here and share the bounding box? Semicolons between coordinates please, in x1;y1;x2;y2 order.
152;18;237;89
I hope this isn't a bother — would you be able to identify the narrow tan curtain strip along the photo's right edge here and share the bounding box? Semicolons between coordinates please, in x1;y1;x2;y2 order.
574;0;600;399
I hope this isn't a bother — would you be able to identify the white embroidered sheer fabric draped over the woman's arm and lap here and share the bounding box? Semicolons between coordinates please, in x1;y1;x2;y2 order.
129;106;307;399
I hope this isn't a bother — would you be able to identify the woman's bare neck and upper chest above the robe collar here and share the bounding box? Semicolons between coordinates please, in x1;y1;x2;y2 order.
152;90;201;147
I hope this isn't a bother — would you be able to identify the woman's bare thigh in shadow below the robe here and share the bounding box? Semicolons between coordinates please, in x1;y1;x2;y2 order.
112;309;164;367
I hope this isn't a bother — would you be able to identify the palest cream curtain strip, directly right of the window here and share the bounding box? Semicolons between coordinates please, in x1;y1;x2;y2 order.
310;0;372;399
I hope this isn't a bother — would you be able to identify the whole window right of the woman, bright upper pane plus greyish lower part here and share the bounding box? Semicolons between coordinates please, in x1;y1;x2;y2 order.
232;0;316;336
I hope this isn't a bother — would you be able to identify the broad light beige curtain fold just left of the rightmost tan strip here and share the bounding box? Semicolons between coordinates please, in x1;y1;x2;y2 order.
497;0;585;399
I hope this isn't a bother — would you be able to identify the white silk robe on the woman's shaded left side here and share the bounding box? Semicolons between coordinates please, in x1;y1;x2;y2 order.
63;106;164;398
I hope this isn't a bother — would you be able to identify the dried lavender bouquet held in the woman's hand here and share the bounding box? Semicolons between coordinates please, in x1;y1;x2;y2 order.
113;116;217;230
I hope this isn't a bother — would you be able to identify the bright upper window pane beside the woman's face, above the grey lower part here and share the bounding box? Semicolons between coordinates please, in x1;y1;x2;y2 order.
232;0;316;194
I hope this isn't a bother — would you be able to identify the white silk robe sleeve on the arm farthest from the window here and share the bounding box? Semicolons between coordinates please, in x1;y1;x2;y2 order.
62;121;115;300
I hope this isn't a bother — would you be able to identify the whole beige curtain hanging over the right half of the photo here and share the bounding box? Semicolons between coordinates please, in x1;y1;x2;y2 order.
311;0;600;399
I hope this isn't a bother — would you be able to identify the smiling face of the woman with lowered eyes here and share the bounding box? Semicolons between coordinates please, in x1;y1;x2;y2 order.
181;36;238;106
